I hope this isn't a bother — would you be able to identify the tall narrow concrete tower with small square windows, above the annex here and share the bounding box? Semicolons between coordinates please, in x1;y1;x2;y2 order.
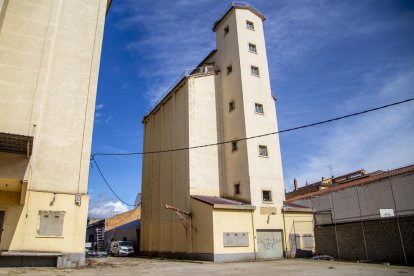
213;2;284;207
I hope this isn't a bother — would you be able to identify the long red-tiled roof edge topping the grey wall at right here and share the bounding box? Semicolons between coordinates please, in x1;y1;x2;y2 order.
286;164;414;202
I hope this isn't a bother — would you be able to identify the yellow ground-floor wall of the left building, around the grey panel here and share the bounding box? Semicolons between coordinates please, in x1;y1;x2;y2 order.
0;191;89;253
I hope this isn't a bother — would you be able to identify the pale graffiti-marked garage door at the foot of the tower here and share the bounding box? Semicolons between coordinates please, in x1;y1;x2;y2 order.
257;230;283;259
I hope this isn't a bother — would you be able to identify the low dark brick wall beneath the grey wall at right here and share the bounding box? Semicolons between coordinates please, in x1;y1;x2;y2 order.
315;216;414;264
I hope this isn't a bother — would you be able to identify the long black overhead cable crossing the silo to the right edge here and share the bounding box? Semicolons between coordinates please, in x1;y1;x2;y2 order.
91;98;414;157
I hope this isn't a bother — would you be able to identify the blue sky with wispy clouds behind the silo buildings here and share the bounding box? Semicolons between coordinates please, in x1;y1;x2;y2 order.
89;0;414;217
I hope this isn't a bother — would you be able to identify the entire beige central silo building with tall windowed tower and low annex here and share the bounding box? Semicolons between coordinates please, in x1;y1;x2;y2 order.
141;5;284;261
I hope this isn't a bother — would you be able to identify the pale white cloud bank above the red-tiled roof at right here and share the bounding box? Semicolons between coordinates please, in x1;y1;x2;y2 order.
285;71;414;190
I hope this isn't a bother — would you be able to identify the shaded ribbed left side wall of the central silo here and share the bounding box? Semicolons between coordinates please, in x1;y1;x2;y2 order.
141;82;191;252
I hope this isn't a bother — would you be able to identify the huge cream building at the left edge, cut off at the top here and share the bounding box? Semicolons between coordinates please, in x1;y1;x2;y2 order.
0;0;110;266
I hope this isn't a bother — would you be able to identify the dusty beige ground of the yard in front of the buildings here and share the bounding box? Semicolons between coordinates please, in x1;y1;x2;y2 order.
0;257;414;276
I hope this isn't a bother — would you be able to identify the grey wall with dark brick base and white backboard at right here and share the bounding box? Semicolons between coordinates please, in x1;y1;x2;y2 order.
310;174;414;264
